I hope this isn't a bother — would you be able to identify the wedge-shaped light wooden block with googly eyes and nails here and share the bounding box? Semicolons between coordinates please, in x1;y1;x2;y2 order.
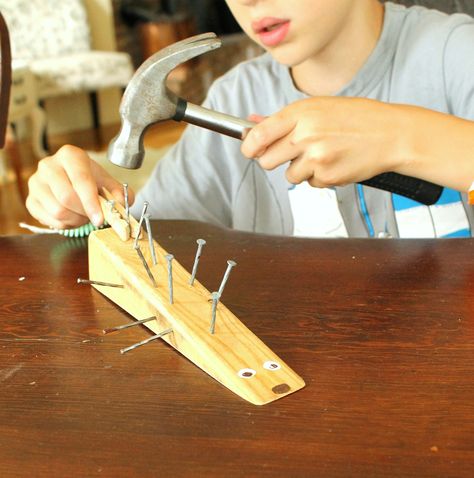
89;190;305;405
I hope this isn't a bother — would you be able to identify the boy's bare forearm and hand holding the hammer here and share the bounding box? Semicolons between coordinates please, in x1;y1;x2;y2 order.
242;97;474;191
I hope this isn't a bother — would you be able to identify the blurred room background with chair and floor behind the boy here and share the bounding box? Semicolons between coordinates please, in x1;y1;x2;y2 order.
0;0;474;235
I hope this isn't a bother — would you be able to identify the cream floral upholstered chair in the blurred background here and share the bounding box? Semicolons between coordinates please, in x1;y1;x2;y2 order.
0;0;133;140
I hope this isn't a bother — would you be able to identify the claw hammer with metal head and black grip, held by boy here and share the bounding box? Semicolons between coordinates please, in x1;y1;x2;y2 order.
108;33;443;205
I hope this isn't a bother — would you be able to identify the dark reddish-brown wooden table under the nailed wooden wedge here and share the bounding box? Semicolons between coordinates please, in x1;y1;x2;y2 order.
0;221;474;477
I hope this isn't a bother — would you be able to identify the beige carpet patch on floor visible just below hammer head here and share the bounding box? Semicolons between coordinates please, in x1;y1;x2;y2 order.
87;146;170;196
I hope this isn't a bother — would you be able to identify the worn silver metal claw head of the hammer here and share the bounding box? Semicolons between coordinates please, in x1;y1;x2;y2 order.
108;33;221;169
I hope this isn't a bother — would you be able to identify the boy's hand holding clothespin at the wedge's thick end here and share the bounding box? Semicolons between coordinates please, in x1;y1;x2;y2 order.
26;146;134;229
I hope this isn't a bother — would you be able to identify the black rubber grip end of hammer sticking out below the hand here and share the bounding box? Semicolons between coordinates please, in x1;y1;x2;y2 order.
361;173;443;206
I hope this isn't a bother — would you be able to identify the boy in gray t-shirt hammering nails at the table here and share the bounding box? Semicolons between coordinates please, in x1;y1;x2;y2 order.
27;0;474;237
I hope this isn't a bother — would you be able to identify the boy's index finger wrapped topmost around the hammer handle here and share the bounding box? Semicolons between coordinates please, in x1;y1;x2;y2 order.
241;114;296;158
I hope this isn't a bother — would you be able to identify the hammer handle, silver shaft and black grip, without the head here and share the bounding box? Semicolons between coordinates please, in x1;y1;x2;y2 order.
173;98;443;206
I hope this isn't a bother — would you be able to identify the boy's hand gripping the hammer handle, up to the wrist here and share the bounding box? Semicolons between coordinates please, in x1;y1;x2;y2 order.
242;97;404;187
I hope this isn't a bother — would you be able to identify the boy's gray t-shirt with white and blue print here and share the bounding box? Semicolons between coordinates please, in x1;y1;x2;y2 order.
132;3;474;237
